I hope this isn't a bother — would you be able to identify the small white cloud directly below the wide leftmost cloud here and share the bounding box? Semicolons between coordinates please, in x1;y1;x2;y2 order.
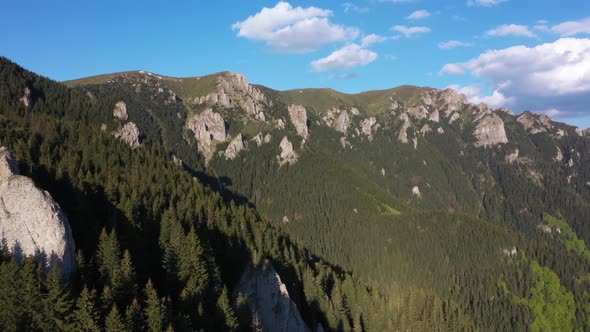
311;44;377;71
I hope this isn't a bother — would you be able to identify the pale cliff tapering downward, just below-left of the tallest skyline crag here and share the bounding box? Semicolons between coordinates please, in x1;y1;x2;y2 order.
187;108;226;163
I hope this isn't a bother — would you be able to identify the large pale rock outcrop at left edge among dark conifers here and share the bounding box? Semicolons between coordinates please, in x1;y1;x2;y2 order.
0;148;75;275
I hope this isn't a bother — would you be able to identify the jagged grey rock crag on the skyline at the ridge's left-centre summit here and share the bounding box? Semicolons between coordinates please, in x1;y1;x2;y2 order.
196;73;266;121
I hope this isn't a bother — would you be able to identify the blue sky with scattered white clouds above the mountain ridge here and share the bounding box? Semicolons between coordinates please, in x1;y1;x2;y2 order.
0;0;590;128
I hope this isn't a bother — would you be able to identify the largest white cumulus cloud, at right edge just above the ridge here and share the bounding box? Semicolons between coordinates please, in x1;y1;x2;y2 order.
441;38;590;115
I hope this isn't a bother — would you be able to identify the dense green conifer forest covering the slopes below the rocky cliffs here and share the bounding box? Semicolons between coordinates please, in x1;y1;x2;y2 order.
0;59;590;331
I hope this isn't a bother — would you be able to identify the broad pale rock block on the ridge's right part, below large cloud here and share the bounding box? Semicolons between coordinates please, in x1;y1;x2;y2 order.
473;103;508;147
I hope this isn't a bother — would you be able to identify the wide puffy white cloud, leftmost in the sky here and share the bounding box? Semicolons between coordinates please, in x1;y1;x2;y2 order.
232;1;359;53
